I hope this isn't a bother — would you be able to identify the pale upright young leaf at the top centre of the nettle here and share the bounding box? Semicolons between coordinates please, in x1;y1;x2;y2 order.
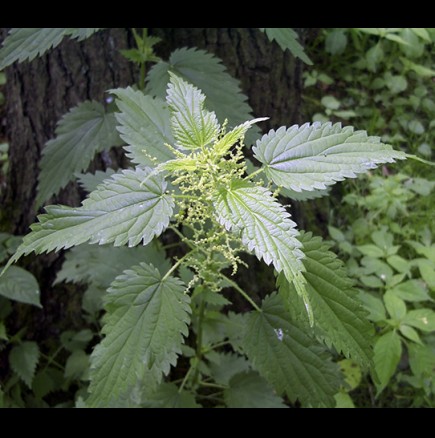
166;72;219;149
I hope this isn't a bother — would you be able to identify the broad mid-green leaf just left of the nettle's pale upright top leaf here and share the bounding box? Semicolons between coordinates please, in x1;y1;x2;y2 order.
111;87;175;166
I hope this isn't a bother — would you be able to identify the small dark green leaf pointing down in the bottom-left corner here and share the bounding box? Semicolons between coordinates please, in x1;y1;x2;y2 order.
9;341;39;388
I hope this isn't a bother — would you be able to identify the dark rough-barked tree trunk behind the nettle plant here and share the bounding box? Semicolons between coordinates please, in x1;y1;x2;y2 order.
0;28;312;362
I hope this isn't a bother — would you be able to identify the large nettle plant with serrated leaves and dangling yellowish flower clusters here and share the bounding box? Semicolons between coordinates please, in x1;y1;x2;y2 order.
0;28;406;407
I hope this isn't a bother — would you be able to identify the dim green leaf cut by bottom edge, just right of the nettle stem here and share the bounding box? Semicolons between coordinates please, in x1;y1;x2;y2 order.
224;371;287;408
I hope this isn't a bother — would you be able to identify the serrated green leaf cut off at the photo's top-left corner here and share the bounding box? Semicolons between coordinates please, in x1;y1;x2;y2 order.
0;27;100;70
